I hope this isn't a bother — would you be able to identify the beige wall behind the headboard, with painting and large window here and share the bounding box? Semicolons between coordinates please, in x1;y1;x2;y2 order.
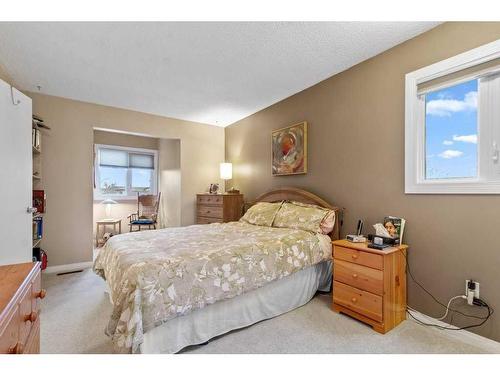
226;23;500;340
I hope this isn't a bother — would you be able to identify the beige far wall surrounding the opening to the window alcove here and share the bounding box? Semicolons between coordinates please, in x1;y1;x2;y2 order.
29;93;224;266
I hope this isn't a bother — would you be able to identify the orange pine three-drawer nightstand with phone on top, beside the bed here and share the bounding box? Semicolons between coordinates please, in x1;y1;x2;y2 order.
332;240;408;333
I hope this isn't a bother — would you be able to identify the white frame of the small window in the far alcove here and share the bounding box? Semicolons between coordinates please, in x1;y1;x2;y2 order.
94;144;158;200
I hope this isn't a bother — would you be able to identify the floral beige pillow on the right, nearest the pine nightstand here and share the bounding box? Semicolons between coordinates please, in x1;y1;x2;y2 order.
273;202;335;234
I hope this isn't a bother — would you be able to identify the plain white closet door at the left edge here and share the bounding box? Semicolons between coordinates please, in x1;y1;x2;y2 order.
0;80;33;265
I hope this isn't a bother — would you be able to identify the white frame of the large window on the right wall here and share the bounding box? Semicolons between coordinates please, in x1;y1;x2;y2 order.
405;39;500;194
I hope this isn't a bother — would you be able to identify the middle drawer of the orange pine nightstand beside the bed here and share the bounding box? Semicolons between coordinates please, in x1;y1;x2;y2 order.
333;259;384;295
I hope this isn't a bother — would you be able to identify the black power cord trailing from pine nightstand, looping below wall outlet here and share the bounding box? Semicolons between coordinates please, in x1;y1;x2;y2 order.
400;249;495;331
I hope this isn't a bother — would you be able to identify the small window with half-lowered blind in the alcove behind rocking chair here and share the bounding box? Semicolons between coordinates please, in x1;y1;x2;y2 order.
94;145;158;199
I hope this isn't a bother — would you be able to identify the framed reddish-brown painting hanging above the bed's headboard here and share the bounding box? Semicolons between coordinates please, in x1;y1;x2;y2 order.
271;121;307;176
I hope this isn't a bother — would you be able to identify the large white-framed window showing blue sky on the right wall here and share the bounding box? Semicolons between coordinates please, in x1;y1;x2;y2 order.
405;41;500;194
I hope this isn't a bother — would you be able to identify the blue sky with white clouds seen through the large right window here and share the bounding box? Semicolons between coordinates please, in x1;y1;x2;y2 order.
425;80;478;179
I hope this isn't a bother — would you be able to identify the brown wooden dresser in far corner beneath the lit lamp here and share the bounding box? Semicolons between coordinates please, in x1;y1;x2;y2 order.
196;193;243;224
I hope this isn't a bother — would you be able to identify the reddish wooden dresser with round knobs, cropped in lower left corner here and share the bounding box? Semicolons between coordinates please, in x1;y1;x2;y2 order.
0;262;45;354
